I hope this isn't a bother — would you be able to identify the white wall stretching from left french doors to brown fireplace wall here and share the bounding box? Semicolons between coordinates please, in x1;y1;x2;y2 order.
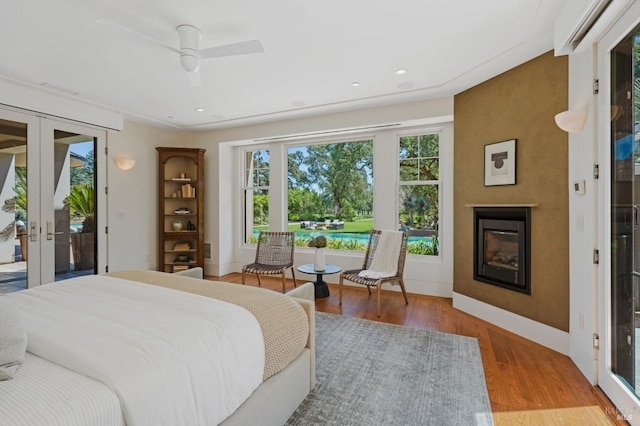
107;98;453;297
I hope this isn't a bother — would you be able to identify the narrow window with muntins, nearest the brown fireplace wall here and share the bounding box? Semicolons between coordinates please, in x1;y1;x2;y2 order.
398;133;440;256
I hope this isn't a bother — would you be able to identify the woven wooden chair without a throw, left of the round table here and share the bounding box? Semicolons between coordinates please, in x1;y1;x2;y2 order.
242;231;298;293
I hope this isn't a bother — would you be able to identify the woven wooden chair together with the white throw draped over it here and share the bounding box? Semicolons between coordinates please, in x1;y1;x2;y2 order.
339;229;409;316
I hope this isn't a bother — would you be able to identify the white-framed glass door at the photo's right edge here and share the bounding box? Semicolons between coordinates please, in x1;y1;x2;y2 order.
597;3;640;424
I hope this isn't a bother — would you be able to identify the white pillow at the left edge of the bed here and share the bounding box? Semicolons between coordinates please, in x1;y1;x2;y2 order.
0;296;27;381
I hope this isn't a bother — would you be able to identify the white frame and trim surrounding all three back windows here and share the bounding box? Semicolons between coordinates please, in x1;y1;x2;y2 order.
234;119;454;262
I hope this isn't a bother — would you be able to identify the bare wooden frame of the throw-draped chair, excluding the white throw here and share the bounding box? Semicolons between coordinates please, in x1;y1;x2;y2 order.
338;229;409;316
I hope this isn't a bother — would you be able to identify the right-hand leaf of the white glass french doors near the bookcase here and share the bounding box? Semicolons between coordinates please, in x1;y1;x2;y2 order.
41;121;101;283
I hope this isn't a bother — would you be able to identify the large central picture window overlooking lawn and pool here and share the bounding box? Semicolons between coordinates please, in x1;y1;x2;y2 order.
287;140;373;251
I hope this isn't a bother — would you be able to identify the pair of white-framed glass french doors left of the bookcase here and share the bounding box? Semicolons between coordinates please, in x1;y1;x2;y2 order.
0;109;106;292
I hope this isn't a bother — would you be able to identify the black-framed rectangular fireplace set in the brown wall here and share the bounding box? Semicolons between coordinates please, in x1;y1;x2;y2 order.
473;207;531;294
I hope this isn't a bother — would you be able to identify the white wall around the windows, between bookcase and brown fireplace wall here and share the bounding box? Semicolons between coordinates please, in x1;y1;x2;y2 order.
182;98;453;297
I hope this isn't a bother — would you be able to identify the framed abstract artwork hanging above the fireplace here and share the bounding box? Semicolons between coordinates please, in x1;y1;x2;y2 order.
484;139;516;186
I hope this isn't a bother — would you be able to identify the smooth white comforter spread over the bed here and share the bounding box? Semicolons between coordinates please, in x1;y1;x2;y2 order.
10;275;264;426
